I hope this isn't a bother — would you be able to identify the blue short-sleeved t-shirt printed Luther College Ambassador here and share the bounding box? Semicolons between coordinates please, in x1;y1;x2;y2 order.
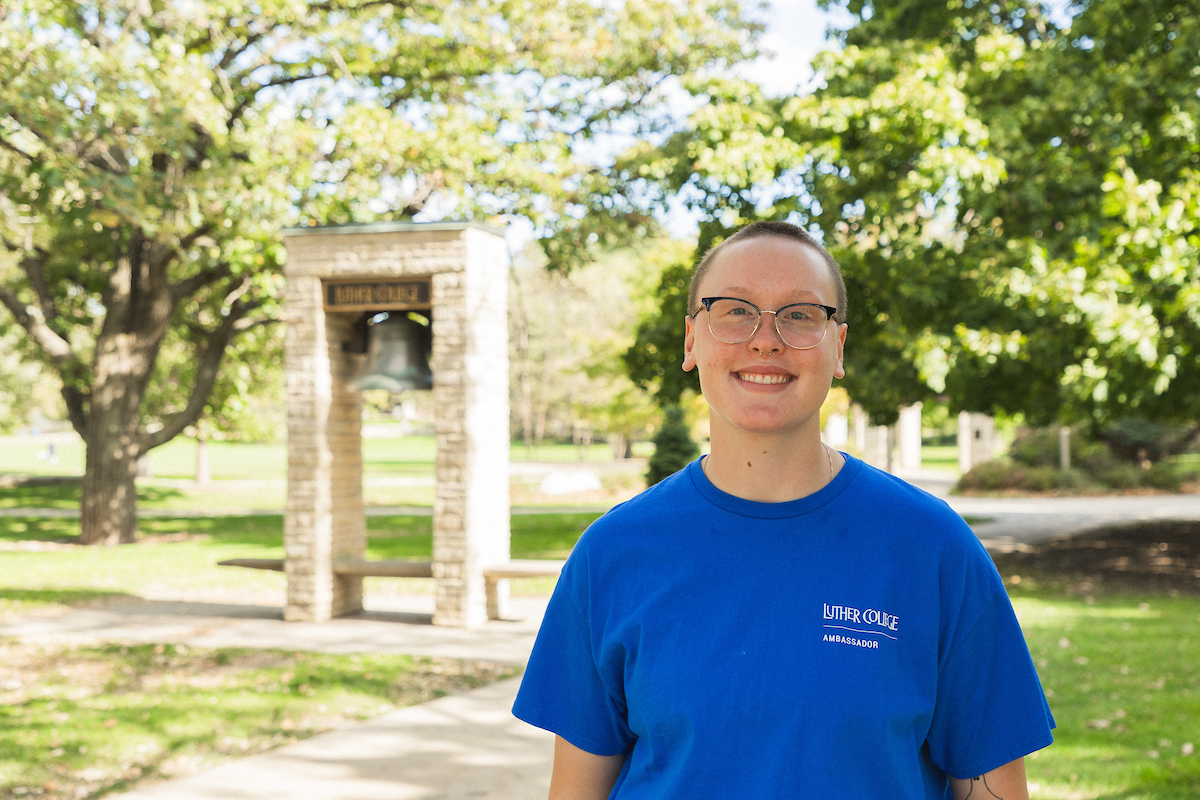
514;457;1054;800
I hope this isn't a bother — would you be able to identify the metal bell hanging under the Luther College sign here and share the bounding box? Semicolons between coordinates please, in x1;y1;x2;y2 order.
355;311;433;392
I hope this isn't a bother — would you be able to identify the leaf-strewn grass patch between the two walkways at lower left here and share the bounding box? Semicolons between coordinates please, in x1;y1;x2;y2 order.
0;642;517;800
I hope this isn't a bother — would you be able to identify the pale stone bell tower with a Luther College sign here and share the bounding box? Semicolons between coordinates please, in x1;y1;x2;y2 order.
282;222;509;627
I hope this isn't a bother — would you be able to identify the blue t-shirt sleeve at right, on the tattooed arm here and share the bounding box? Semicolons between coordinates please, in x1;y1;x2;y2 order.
926;589;1055;778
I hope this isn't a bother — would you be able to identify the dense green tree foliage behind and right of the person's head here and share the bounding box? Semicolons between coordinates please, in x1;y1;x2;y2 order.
625;0;1200;427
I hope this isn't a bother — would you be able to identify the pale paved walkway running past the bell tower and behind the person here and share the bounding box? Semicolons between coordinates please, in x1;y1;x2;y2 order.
7;489;1200;800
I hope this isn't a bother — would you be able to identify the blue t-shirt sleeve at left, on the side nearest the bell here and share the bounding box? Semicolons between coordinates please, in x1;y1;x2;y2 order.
512;557;636;756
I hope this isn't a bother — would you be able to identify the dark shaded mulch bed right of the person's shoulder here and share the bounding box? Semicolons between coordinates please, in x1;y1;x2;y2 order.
992;522;1200;595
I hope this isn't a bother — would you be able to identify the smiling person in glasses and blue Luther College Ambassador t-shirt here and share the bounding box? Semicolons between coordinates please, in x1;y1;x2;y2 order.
512;222;1054;800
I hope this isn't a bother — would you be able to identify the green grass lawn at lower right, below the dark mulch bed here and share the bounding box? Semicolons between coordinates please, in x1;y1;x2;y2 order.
1013;590;1200;800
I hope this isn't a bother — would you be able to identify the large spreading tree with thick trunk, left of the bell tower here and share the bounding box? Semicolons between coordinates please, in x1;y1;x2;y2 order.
0;0;755;543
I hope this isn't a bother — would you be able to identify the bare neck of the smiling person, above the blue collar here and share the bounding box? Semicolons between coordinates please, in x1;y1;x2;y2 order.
703;427;844;503
